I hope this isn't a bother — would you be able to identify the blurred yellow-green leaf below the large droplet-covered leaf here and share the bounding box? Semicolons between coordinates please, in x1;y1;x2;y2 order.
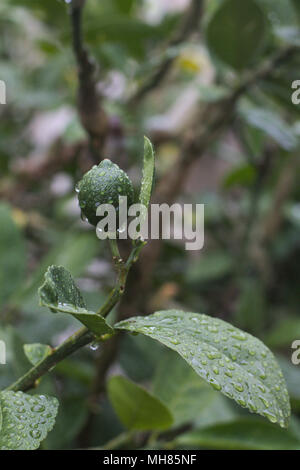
108;376;173;431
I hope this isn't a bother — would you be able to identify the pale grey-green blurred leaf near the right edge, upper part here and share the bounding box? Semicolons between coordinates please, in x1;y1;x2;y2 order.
240;107;298;151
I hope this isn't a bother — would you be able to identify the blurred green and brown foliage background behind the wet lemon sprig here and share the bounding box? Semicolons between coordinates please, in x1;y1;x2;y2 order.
0;0;300;449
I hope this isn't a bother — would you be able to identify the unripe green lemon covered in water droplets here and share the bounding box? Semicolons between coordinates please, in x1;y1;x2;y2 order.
76;159;134;226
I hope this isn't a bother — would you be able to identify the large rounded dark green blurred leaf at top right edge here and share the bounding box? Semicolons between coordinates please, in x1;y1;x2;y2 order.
206;0;267;70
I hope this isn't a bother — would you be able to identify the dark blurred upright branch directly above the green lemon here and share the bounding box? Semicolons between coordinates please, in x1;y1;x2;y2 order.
71;0;108;161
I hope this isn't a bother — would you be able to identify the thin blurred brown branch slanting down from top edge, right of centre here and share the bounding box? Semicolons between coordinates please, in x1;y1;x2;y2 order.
128;0;203;106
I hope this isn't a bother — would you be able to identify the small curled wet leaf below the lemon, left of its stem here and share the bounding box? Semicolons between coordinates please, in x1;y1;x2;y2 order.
39;266;113;336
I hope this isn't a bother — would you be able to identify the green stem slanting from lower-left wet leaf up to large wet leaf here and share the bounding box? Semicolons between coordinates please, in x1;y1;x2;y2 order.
6;328;94;392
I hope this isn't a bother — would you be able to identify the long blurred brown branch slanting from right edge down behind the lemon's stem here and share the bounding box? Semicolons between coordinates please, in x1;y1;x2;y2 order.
122;46;299;317
